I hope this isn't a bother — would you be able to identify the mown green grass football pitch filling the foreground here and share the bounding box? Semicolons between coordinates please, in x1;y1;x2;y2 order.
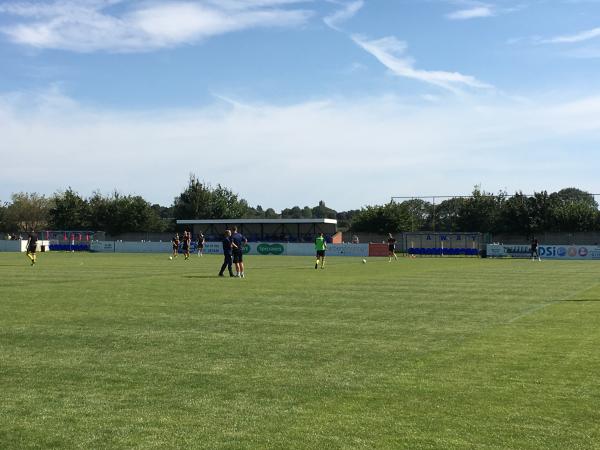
0;253;600;450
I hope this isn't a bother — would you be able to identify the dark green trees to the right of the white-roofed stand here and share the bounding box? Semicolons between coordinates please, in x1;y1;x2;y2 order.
352;186;600;236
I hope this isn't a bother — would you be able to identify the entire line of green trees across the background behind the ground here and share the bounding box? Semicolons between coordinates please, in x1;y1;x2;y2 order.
0;175;600;236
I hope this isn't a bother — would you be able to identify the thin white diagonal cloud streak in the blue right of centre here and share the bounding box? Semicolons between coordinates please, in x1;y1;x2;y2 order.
352;35;492;92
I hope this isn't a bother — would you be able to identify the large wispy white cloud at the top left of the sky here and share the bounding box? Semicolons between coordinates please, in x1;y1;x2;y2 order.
0;0;312;52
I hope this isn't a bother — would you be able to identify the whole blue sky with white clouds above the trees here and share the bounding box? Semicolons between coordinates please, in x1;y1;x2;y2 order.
0;0;600;210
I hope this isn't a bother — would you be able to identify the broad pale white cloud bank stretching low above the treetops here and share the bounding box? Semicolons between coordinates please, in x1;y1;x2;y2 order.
0;89;600;210
